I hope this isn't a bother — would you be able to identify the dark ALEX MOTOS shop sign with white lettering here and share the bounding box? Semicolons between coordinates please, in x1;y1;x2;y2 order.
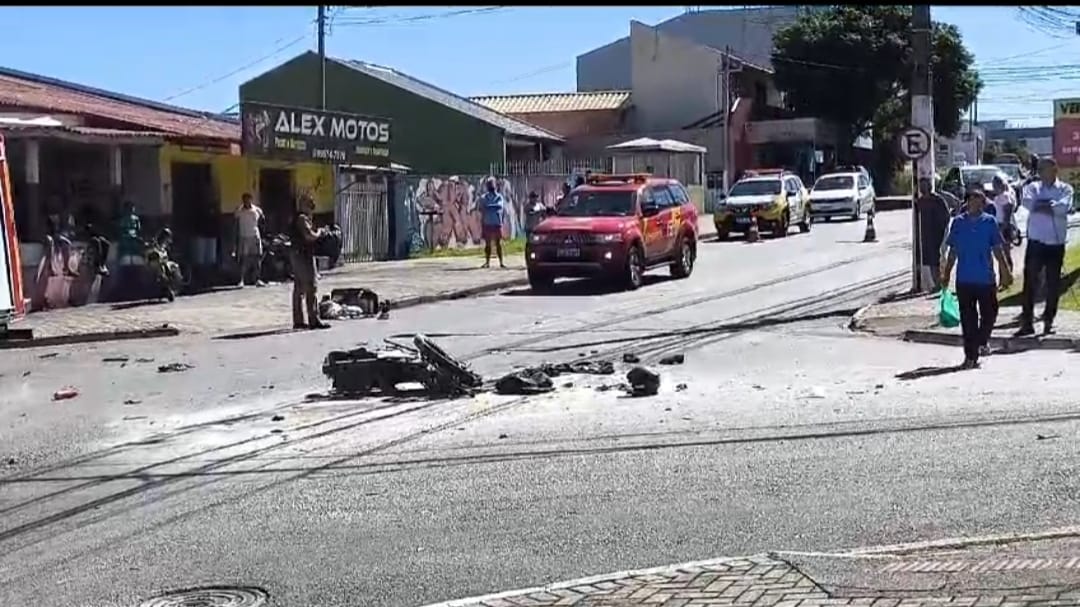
240;102;391;166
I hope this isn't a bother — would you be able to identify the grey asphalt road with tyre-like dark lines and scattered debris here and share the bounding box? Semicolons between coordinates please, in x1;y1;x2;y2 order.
0;212;1078;607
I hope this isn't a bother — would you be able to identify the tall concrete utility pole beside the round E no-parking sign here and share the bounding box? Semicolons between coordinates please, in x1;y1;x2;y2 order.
912;4;935;293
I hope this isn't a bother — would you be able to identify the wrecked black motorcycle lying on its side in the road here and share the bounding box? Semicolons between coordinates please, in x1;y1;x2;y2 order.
323;335;483;397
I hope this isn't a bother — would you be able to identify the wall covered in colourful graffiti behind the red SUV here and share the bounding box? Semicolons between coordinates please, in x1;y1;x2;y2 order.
403;174;568;253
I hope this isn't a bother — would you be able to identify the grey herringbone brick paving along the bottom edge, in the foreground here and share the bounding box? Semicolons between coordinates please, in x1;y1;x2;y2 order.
431;556;1080;607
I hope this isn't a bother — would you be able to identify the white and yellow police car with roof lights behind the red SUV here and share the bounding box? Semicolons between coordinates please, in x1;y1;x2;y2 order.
713;170;813;240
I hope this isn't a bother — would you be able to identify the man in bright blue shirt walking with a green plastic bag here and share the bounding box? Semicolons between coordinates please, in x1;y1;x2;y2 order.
942;189;1012;368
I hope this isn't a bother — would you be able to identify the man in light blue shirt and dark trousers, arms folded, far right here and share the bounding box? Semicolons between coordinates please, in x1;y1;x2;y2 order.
1016;158;1072;337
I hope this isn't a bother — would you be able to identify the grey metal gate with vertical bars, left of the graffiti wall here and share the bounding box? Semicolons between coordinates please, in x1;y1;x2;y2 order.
334;176;390;261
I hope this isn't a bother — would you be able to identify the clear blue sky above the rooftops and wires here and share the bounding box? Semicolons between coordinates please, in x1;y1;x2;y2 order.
0;6;1080;124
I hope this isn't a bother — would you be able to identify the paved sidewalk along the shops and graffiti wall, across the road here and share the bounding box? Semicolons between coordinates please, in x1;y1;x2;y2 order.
13;215;716;345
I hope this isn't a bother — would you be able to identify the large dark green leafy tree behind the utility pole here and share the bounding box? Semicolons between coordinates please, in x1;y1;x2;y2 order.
772;5;982;149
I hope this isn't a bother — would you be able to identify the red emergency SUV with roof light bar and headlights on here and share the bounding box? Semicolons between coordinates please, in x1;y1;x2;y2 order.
525;175;698;291
